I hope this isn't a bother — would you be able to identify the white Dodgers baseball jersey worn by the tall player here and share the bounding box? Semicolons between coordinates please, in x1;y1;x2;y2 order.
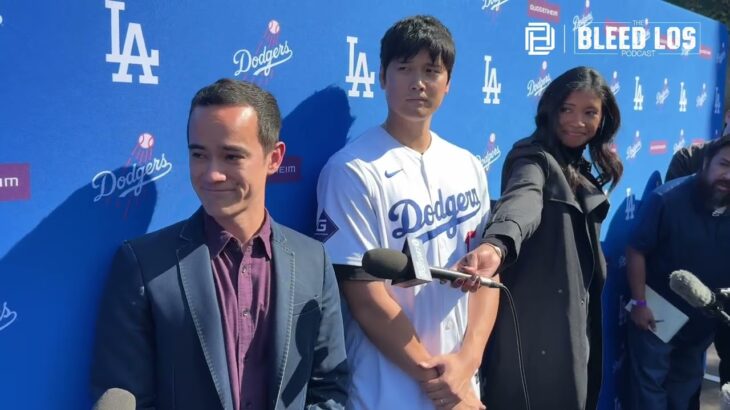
315;127;489;409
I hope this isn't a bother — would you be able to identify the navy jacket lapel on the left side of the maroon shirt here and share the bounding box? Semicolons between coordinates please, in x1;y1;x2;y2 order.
177;210;233;410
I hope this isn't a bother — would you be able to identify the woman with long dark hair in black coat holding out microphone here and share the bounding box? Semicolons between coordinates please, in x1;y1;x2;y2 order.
461;67;623;410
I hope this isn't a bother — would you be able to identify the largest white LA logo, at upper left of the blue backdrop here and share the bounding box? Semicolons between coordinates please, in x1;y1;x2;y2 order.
104;0;160;84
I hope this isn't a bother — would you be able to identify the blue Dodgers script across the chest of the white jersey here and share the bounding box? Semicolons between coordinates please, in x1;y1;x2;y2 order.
388;188;482;242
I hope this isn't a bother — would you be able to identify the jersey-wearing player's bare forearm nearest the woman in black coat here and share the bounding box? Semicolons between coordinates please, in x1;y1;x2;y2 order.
459;275;499;371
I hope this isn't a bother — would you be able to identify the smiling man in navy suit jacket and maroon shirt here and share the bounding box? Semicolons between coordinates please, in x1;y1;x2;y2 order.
91;79;349;410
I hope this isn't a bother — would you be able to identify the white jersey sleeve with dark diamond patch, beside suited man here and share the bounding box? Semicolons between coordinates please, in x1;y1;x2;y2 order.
315;155;381;280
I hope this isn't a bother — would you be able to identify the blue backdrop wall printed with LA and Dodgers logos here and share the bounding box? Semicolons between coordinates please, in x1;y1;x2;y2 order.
0;0;728;409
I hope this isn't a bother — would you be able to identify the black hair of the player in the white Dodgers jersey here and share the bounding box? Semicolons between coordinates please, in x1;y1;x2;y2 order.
380;16;456;80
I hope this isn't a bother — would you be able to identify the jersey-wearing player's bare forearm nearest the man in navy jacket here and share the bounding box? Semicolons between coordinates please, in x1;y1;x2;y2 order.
342;281;438;381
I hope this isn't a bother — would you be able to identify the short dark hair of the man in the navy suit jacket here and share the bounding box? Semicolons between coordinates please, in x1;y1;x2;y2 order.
188;78;281;152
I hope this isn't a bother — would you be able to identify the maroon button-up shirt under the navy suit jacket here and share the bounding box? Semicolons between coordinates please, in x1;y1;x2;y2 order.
205;212;274;410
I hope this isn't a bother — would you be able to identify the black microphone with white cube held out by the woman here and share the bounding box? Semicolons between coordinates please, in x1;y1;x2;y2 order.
362;246;504;288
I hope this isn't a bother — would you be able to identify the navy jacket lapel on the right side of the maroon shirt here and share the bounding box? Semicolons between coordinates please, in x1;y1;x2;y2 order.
269;220;295;408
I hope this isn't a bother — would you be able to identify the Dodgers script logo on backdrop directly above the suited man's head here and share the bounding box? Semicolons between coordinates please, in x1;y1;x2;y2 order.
233;20;294;85
